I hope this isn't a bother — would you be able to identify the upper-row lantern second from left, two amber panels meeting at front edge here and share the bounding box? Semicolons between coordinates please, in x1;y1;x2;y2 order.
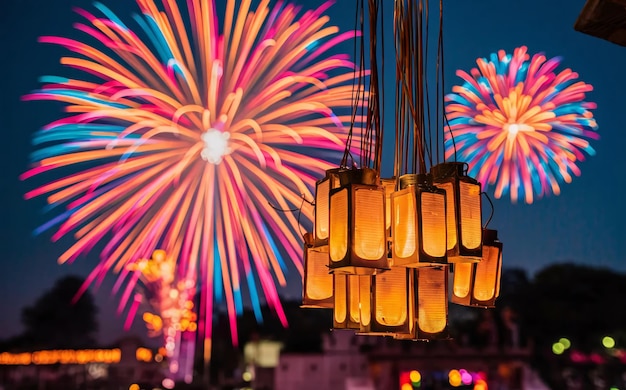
329;168;389;275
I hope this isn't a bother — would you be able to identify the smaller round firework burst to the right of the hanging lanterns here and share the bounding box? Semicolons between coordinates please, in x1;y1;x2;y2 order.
446;46;598;203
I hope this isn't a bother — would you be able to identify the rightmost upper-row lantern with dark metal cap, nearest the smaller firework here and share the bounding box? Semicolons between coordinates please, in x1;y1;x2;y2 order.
431;162;482;263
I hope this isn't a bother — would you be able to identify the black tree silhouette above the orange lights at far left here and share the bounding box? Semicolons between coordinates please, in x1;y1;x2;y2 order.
20;276;98;349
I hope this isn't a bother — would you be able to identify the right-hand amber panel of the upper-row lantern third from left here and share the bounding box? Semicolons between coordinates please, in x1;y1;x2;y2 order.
421;192;444;257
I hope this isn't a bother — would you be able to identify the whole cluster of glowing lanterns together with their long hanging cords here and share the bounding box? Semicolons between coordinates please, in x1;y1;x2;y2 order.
303;0;502;340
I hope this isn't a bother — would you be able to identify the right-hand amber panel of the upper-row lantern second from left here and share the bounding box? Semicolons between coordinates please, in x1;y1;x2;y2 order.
354;189;386;260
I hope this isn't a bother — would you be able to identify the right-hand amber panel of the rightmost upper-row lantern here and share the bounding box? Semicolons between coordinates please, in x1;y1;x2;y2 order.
459;181;483;249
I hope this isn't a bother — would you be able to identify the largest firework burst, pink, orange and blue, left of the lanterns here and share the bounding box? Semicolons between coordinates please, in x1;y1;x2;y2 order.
23;0;361;342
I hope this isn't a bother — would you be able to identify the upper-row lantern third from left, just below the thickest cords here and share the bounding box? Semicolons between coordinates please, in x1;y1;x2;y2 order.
391;174;447;267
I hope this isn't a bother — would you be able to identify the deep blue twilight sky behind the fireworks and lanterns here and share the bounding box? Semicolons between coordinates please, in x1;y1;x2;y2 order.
0;0;626;342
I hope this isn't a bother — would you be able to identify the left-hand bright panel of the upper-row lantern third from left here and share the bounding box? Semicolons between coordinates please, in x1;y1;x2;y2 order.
393;190;417;259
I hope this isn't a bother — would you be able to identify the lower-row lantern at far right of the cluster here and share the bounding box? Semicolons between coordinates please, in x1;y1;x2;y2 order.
451;229;502;307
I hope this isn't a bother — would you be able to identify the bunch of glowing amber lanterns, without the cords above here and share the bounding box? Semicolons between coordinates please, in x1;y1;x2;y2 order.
303;163;502;340
